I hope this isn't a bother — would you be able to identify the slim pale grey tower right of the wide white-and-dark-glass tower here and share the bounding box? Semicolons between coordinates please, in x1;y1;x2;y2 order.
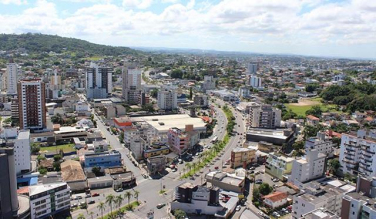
122;66;141;104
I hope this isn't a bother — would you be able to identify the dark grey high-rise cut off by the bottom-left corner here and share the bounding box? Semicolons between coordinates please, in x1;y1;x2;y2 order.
0;148;19;218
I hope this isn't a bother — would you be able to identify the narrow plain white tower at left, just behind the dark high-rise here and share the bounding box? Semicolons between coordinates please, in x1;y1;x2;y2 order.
14;130;31;175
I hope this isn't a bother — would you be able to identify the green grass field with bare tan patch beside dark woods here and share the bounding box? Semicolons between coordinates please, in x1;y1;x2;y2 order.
285;97;338;116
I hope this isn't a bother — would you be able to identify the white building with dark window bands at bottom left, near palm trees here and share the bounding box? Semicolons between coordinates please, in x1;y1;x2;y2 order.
29;182;71;219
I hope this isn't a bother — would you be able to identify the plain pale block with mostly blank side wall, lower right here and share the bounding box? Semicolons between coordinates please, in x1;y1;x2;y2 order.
289;149;326;186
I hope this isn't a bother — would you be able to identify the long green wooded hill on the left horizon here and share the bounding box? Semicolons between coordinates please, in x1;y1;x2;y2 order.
0;33;139;56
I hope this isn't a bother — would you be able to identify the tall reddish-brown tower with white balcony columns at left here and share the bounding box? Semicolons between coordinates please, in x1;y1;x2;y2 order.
18;79;46;130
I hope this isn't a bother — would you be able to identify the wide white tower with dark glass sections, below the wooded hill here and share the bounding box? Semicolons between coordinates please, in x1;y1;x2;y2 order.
86;62;113;99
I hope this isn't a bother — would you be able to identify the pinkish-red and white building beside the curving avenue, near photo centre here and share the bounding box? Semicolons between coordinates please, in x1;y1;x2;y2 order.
167;125;200;155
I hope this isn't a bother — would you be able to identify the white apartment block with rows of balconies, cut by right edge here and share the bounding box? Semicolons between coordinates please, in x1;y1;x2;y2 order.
339;130;376;177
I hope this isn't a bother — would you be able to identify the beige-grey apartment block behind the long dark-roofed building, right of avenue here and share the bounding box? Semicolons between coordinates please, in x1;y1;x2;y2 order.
248;105;282;129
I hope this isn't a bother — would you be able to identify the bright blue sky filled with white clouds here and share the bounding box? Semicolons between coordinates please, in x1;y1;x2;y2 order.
0;0;376;59
